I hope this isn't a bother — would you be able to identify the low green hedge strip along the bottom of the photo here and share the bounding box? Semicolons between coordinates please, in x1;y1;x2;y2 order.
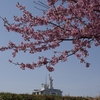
0;92;93;100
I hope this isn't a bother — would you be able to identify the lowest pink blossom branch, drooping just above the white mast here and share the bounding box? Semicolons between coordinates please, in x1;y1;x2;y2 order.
9;39;93;72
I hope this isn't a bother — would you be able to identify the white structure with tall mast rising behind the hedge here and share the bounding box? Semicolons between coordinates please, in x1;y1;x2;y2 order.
33;75;62;96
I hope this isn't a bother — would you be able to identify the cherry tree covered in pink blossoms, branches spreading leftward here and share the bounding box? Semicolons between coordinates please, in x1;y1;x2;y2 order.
0;0;100;71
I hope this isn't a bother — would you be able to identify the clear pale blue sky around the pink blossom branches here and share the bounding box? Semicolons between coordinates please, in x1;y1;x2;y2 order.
0;0;100;96
